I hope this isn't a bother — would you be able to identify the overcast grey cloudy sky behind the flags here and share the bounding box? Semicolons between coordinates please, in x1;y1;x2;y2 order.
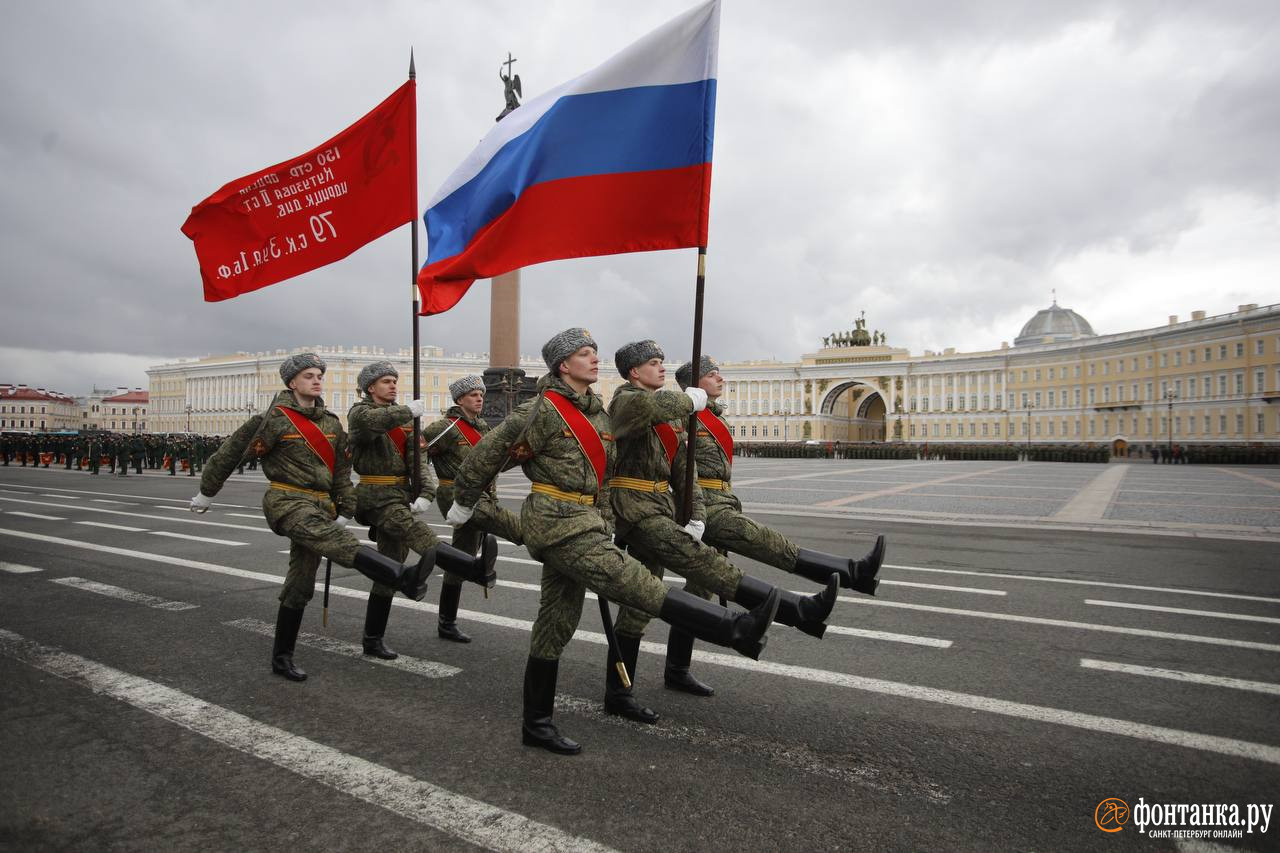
0;0;1280;393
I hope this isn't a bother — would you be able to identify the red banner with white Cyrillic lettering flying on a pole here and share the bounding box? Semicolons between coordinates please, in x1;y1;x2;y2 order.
182;79;417;302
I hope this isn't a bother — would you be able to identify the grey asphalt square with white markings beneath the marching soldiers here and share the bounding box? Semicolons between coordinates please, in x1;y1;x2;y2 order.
0;459;1280;850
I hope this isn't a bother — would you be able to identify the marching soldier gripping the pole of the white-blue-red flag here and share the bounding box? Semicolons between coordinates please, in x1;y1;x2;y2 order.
604;341;840;722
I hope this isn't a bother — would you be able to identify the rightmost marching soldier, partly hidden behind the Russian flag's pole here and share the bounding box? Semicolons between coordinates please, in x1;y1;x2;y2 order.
663;356;884;695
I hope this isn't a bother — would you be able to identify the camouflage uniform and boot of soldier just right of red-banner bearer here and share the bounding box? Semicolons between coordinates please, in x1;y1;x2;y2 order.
422;406;525;643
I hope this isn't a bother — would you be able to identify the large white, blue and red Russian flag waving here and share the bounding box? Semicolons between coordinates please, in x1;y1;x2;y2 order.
417;0;719;314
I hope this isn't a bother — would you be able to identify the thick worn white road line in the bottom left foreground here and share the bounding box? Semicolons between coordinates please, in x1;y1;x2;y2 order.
0;629;609;853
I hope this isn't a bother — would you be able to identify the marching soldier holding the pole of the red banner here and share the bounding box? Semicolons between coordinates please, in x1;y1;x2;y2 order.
347;361;498;661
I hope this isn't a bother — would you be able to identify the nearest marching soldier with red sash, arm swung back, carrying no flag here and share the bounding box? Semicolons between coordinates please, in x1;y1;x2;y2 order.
445;329;778;754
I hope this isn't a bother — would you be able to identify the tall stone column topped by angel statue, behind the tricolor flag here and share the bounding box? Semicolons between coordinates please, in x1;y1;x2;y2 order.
483;53;538;425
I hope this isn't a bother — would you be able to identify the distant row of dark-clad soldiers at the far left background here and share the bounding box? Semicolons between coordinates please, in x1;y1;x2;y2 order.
0;433;227;476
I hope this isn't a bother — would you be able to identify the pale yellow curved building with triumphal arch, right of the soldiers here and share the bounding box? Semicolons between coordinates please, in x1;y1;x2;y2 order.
713;304;1280;453
